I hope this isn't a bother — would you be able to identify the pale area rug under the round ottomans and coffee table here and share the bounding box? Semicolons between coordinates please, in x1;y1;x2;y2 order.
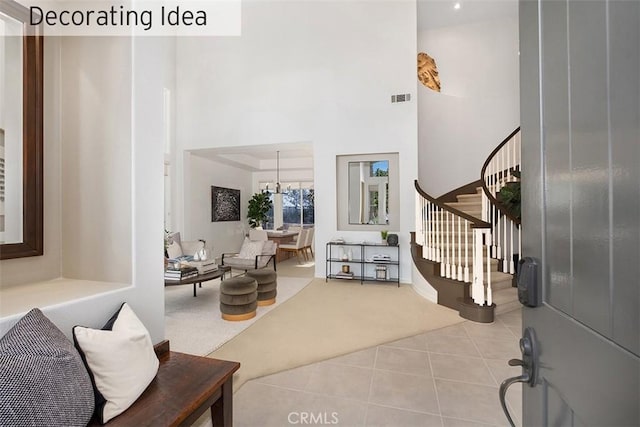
164;276;311;356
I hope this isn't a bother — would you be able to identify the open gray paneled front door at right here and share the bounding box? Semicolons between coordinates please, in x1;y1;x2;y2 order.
520;0;640;426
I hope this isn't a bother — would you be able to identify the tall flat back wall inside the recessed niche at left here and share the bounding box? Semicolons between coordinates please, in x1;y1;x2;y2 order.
60;37;133;283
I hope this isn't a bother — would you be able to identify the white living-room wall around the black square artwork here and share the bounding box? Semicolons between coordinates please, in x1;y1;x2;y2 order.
181;153;254;257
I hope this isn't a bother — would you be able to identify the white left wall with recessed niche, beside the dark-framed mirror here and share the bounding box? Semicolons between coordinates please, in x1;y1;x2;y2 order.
0;37;175;342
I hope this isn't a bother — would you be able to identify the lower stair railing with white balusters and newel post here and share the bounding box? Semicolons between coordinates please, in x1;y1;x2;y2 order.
415;181;492;305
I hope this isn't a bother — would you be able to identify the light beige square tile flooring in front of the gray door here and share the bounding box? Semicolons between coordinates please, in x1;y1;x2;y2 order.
233;310;522;427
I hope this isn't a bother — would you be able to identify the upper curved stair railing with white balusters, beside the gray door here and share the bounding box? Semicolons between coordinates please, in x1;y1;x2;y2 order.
481;128;521;274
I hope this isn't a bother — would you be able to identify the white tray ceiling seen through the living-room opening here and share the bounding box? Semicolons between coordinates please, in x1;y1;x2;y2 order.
191;142;313;172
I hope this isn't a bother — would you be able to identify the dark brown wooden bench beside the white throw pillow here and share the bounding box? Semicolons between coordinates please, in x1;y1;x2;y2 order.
89;340;240;427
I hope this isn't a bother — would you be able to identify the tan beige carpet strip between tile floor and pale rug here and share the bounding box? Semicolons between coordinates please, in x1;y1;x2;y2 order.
209;279;463;390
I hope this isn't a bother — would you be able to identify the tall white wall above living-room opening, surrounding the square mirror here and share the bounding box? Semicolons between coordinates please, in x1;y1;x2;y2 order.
176;1;417;281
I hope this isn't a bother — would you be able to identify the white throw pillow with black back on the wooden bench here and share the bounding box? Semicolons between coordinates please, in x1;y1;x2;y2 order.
73;303;160;424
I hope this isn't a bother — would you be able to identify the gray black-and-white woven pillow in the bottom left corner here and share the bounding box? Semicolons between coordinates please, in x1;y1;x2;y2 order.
0;308;94;426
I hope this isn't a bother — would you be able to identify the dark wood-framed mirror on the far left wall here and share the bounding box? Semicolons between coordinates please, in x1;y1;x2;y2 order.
0;0;44;260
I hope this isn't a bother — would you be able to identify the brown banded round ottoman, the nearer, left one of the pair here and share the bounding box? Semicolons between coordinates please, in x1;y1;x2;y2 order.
220;276;258;321
